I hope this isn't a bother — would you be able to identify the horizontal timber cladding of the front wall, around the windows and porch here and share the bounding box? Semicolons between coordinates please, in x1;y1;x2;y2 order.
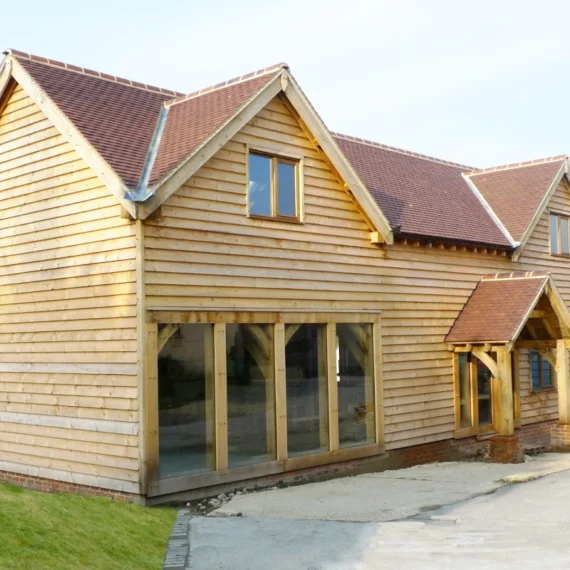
145;91;570;449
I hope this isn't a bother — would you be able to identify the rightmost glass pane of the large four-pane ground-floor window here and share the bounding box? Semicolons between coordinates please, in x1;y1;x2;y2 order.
336;324;375;447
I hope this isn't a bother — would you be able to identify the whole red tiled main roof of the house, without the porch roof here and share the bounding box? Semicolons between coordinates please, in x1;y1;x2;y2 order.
3;50;562;248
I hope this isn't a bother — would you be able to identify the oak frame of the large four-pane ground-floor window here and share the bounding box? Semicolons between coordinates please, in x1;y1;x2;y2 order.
144;311;385;497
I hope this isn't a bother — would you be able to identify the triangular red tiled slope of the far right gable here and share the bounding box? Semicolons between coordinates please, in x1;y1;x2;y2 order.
468;156;566;241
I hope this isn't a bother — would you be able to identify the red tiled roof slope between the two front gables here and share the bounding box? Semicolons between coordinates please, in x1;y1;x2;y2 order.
334;134;511;248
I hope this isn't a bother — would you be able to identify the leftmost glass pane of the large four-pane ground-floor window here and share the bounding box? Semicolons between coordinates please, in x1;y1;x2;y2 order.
158;324;215;479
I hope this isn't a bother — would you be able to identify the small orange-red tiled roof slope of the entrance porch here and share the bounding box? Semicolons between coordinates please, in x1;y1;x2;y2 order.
445;272;549;343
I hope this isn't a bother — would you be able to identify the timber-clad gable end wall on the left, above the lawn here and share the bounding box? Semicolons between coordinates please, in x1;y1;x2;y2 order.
0;82;139;493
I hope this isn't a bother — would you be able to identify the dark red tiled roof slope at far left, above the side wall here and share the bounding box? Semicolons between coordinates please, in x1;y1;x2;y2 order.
10;51;178;187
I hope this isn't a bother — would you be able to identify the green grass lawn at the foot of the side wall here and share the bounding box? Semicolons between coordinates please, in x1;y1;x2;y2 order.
0;485;176;570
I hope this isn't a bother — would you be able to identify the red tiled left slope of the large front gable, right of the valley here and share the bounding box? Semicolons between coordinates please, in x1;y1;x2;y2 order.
150;64;287;184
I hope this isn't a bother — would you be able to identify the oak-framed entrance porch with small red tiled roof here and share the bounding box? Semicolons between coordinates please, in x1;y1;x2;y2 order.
446;272;570;462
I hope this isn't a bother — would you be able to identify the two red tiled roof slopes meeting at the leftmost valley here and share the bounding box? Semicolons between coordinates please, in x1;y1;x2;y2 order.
7;50;287;188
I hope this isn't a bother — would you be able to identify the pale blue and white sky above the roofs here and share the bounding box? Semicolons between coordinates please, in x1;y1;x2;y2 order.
1;0;570;166
